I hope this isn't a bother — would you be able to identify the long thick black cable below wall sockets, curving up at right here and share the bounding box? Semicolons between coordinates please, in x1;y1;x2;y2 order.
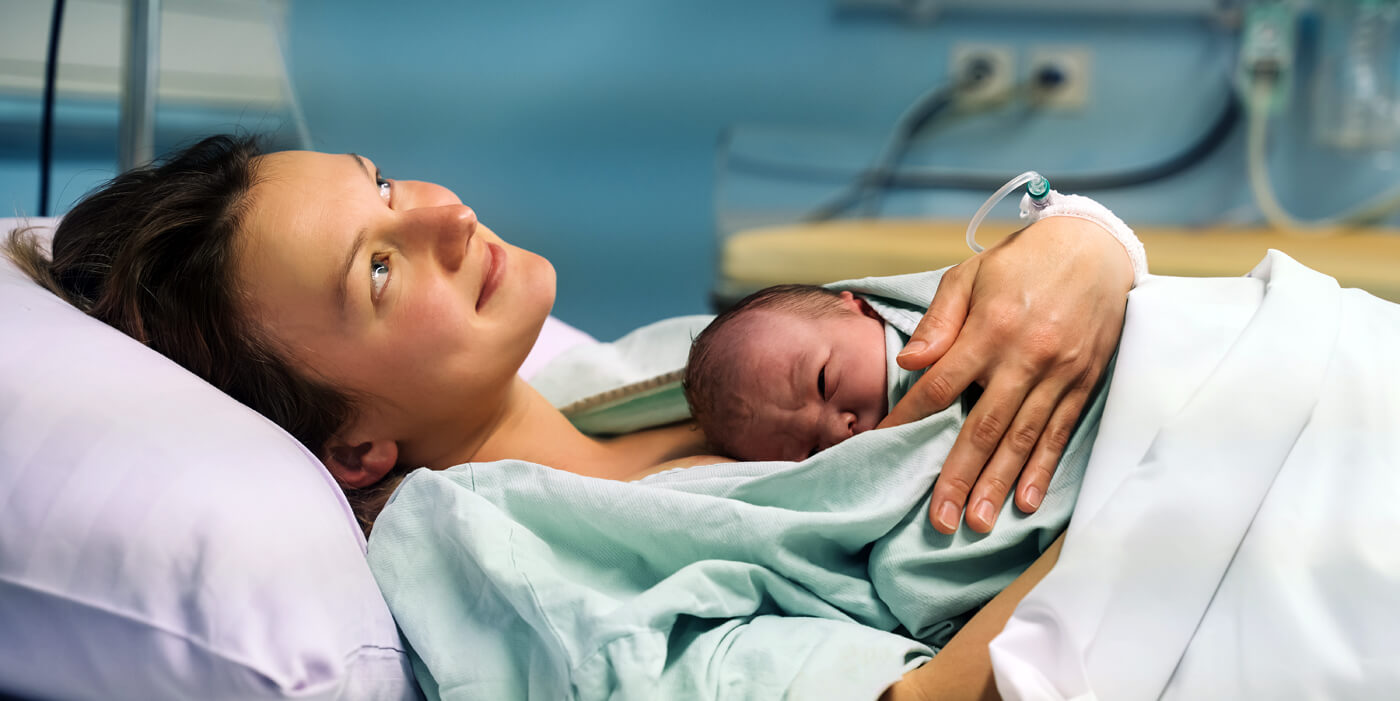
729;91;1242;201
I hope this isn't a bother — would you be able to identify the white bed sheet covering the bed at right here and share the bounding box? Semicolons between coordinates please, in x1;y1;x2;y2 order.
991;252;1400;701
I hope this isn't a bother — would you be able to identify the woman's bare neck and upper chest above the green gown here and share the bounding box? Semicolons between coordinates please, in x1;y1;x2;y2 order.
469;378;703;480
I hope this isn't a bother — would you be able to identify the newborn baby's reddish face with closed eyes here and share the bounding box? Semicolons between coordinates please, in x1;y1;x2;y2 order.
731;299;886;460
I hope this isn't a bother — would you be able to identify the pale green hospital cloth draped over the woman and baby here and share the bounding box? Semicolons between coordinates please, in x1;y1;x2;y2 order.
370;265;1103;700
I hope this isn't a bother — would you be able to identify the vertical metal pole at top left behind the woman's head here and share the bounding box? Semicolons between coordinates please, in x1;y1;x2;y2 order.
118;0;161;172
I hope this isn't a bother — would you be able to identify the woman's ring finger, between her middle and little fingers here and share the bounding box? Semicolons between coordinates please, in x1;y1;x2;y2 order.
967;381;1064;533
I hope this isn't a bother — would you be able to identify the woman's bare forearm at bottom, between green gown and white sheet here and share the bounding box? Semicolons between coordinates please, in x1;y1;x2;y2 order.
881;534;1064;701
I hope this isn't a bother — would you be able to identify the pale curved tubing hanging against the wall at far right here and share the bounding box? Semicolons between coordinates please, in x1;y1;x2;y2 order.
1254;77;1400;230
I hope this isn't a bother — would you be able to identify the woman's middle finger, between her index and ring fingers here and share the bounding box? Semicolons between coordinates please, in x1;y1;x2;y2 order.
930;375;1029;533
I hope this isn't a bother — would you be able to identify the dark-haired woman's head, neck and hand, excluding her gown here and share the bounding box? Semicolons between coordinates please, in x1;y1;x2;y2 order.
8;137;1133;696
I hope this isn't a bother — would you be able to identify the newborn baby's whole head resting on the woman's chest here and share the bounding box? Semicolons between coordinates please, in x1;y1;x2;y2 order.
685;285;886;460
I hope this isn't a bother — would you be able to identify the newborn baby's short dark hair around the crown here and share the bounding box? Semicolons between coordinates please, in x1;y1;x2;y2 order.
680;284;855;455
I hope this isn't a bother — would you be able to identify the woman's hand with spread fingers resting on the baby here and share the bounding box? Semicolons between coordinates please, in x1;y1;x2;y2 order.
881;217;1133;533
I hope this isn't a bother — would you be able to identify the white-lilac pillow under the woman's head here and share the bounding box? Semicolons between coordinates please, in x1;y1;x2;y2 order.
0;220;419;700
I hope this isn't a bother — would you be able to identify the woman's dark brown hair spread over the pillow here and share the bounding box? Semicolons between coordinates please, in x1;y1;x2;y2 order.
4;136;392;533
